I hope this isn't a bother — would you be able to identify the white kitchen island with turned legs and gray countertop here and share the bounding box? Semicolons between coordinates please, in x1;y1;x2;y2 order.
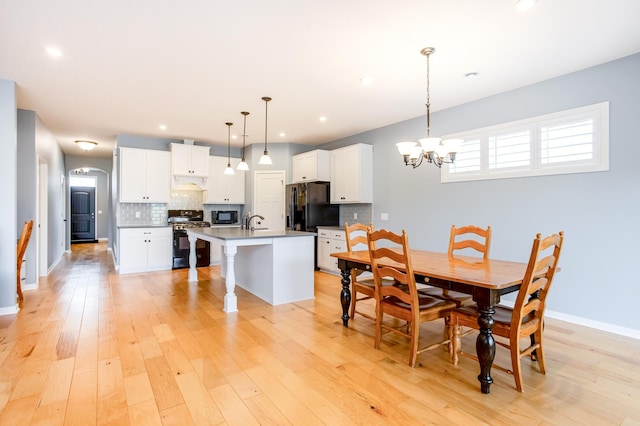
187;228;315;312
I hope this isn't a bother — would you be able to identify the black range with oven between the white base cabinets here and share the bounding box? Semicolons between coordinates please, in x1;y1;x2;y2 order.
168;210;211;269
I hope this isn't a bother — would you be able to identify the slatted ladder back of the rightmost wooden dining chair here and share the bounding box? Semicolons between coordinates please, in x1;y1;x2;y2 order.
511;231;564;335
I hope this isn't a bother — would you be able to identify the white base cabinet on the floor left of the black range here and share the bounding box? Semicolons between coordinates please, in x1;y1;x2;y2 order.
118;227;173;274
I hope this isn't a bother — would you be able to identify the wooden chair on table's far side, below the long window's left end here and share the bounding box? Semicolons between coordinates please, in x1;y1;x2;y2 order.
420;225;491;307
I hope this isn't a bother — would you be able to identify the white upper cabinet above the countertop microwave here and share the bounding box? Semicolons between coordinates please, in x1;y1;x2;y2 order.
203;155;245;204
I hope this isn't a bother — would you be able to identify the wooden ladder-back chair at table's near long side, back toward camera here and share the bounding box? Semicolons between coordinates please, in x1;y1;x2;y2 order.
367;230;456;367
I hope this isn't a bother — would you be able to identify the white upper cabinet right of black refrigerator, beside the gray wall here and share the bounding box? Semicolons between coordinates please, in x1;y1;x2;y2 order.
331;144;373;204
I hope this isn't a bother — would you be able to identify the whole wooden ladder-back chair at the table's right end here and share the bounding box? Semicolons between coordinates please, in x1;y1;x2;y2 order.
447;232;564;392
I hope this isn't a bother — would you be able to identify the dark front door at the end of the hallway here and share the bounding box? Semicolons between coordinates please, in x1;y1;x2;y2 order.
71;186;96;243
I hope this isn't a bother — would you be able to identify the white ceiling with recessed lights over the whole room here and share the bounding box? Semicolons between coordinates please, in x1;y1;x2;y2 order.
0;0;640;156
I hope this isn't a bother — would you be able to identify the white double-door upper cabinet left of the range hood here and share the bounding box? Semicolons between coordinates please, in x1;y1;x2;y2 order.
118;148;171;203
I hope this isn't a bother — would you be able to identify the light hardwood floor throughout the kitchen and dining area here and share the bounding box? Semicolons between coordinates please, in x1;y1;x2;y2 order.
0;243;640;425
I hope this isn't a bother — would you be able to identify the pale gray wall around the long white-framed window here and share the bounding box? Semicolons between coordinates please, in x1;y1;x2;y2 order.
321;54;640;335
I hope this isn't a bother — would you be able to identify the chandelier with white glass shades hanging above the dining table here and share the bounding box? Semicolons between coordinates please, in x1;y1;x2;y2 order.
396;47;462;169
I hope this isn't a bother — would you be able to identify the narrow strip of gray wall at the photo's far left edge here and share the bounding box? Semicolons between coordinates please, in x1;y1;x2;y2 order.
0;79;22;314
